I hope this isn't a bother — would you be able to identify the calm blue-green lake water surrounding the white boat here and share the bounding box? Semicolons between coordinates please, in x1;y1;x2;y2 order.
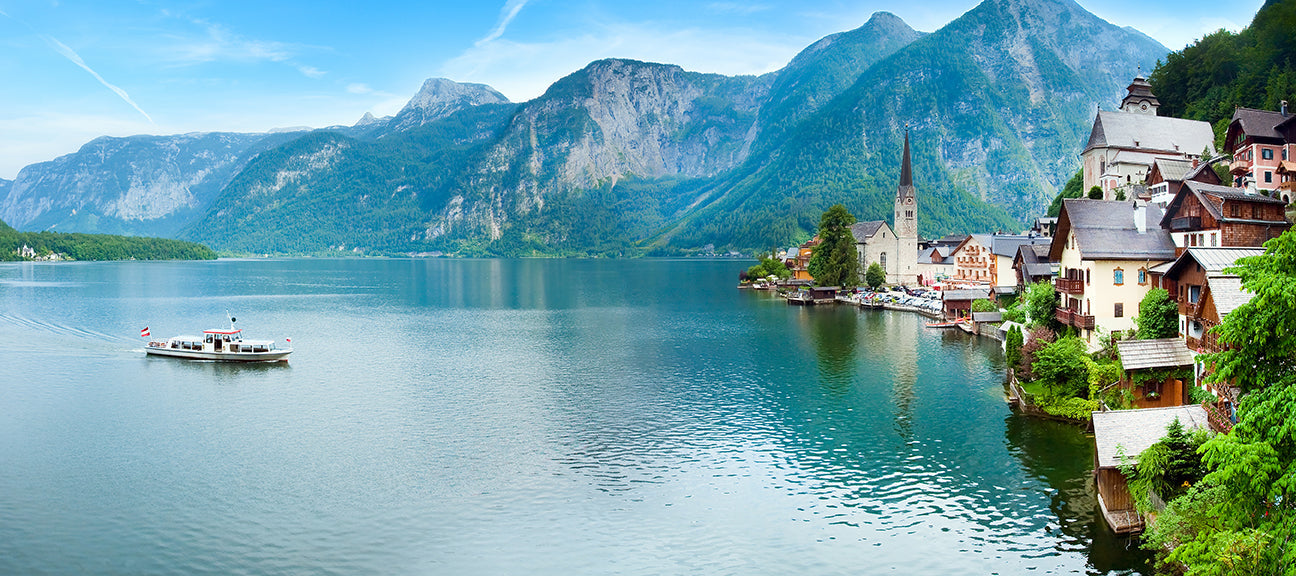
0;259;1147;575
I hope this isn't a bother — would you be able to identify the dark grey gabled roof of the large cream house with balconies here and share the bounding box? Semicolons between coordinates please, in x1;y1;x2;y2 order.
1048;198;1174;262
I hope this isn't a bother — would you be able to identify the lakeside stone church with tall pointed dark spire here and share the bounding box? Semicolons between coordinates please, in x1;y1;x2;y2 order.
850;130;919;285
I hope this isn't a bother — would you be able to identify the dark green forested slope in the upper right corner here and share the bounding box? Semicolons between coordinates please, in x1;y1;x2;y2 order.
1148;0;1296;142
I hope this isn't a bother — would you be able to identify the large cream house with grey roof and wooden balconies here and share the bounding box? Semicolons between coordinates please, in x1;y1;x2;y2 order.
1048;198;1175;348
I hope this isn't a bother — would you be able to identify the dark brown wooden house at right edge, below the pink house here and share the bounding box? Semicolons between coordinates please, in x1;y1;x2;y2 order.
1160;180;1291;256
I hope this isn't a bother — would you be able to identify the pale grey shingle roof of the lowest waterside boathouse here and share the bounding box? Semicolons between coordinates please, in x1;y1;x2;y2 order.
1094;405;1210;468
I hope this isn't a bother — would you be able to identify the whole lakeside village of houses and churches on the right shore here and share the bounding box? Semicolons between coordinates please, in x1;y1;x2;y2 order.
744;77;1296;533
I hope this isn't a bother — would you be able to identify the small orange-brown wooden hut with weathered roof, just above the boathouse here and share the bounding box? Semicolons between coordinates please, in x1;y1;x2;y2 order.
1116;339;1196;409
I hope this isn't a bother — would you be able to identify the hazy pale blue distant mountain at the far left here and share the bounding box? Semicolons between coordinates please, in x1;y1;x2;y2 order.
0;132;267;236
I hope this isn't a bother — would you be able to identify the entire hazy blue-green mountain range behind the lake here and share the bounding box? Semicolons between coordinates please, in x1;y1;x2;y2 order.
0;0;1169;254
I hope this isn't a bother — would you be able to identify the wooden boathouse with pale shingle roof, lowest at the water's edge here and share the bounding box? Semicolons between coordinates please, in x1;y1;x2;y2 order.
1094;406;1210;534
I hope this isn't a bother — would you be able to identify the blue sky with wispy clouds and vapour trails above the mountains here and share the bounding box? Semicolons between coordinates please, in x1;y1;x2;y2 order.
0;0;1262;179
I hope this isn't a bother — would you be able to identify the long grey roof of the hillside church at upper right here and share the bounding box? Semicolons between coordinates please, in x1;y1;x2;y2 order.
1081;110;1214;154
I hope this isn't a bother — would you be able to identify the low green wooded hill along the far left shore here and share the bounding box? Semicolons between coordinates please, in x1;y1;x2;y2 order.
0;222;216;261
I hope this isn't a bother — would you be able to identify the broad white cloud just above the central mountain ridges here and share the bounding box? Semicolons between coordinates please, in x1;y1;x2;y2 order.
438;23;815;101
